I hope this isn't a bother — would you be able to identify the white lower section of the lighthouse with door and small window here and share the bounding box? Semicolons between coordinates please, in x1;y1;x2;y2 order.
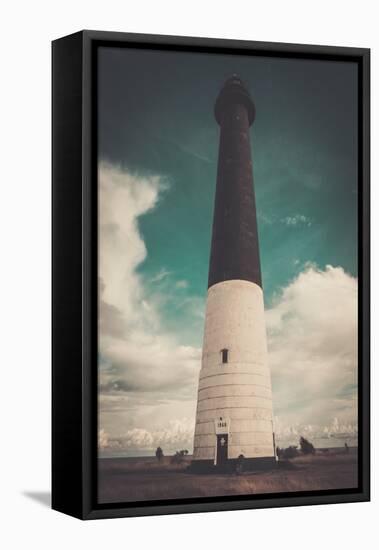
193;280;275;464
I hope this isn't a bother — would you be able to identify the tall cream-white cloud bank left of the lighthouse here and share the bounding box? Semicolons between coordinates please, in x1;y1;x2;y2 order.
99;162;201;458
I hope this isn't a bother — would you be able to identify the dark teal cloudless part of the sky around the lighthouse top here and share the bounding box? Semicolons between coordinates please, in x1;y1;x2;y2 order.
98;48;358;346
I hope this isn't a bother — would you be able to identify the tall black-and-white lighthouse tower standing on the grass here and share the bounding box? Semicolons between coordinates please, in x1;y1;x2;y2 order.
192;75;275;469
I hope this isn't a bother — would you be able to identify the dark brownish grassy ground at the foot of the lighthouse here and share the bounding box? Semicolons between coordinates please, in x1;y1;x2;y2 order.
99;449;357;503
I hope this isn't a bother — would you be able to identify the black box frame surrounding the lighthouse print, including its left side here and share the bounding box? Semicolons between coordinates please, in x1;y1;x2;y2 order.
52;31;370;519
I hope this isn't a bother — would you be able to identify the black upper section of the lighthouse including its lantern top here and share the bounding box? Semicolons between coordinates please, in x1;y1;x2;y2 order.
208;75;262;294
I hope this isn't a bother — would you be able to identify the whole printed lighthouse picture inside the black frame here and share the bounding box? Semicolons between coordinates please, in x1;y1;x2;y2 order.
97;46;359;503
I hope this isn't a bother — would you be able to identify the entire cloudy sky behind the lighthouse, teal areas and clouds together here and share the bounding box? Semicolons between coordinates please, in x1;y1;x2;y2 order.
98;47;358;456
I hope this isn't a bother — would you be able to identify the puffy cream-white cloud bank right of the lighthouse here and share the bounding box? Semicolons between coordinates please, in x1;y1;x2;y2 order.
266;265;358;444
